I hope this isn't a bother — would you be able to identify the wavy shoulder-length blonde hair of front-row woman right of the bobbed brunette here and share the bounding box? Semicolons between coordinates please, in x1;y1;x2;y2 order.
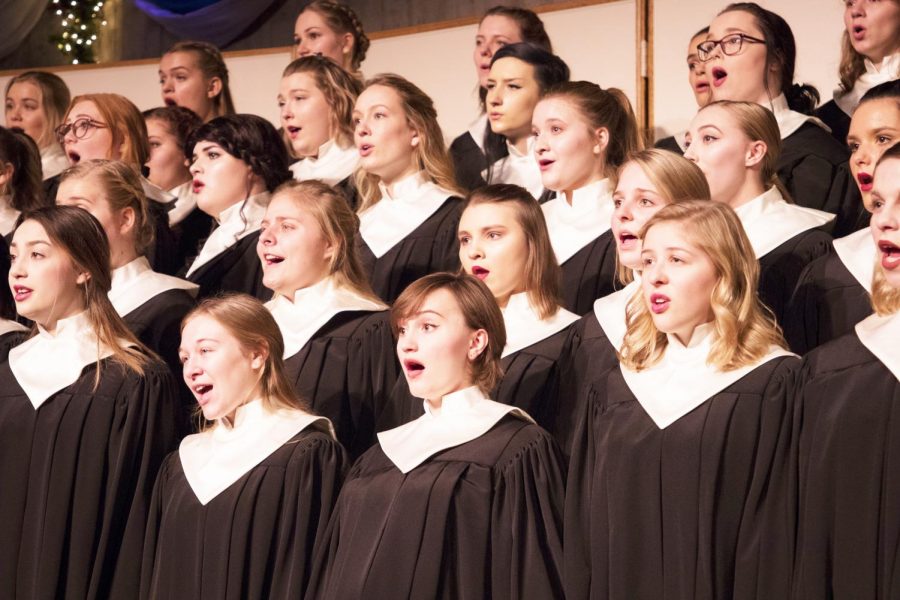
619;200;786;371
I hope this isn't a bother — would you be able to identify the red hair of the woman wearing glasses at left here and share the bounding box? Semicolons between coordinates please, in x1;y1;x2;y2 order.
63;94;150;173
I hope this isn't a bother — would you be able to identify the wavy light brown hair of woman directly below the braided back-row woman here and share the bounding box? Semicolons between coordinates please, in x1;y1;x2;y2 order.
281;54;362;146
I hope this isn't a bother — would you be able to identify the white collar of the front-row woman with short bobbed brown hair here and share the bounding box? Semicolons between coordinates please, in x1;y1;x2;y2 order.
378;386;534;473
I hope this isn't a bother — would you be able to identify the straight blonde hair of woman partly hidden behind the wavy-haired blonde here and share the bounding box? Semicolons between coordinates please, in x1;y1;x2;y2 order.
616;148;710;284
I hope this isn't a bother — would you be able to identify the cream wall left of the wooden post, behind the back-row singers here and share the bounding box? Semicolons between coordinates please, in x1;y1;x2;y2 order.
0;0;637;139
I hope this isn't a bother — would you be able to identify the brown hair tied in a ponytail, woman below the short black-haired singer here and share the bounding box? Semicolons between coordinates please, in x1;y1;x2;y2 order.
541;81;643;177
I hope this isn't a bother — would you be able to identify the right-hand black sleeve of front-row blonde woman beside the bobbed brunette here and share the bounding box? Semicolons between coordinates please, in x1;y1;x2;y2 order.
269;432;348;600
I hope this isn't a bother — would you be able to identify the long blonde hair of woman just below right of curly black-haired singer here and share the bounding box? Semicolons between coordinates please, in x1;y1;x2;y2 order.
272;179;382;304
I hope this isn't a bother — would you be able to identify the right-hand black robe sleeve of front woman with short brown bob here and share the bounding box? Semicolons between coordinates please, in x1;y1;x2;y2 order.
491;425;565;600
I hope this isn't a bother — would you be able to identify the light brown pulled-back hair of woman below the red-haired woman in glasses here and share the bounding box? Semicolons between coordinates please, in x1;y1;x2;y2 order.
59;159;155;255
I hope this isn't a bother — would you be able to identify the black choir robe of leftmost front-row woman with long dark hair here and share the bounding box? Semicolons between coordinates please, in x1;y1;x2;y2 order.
0;359;179;599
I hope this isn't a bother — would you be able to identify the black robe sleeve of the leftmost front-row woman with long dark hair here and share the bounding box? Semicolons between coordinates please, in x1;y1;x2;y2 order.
92;360;180;598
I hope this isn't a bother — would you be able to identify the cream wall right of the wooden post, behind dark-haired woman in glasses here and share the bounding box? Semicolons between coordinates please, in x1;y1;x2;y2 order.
653;0;844;138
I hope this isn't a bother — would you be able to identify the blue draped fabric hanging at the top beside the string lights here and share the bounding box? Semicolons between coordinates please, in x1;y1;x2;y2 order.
134;0;276;47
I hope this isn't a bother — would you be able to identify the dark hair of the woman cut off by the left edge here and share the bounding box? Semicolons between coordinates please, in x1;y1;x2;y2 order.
0;127;44;212
